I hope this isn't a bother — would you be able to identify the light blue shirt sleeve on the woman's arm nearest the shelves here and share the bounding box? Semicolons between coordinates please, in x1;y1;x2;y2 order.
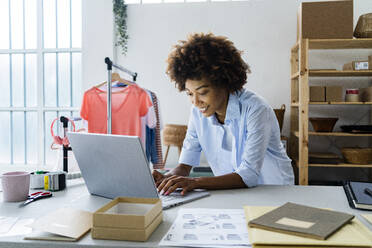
235;106;271;187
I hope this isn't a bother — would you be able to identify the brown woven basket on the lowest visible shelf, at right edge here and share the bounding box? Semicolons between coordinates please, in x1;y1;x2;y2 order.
341;147;372;164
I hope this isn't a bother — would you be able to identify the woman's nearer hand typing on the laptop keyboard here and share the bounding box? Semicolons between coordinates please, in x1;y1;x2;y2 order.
158;176;197;195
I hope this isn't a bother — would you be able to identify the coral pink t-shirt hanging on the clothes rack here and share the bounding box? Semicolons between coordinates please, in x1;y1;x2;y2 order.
80;85;152;137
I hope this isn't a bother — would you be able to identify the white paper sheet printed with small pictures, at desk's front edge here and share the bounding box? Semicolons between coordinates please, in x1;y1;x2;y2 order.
159;208;250;248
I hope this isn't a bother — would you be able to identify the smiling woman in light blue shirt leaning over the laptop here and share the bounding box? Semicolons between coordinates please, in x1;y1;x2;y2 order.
153;33;294;195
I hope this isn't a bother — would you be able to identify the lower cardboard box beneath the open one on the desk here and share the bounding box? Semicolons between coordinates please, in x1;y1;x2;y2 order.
92;213;163;241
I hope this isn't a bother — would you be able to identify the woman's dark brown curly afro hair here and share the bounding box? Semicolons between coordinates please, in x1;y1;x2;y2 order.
166;33;250;93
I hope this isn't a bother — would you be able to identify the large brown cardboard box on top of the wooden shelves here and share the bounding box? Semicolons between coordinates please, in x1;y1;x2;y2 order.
297;0;353;39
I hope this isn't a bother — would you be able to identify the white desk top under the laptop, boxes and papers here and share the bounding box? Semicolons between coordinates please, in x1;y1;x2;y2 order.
0;179;372;248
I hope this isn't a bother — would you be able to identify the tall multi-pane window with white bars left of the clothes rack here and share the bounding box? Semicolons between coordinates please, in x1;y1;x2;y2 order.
0;0;82;168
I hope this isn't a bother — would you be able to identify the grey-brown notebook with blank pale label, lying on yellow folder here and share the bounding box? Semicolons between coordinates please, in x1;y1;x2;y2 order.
248;202;354;240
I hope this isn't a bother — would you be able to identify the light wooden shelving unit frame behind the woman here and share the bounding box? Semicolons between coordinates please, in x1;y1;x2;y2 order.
289;39;372;185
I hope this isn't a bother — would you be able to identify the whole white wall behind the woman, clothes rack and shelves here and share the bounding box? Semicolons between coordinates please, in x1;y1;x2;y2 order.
83;0;372;170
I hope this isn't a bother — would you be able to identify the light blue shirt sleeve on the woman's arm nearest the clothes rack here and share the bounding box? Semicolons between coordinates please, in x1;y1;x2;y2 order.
179;109;202;166
